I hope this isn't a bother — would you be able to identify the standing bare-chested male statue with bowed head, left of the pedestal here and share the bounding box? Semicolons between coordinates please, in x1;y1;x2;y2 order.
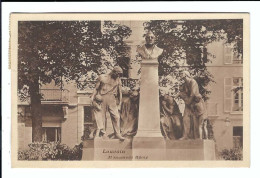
91;66;124;140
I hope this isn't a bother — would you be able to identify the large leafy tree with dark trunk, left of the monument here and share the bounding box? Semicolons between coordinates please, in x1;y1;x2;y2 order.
18;21;131;142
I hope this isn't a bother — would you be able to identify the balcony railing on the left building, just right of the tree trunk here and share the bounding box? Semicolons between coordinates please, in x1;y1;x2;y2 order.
40;89;69;102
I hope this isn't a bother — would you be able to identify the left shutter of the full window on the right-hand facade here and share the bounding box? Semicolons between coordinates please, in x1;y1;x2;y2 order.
224;78;232;112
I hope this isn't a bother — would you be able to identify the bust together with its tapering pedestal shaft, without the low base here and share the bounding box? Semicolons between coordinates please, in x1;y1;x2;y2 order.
135;32;163;138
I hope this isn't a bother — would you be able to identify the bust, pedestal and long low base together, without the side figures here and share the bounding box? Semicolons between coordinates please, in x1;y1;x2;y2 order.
82;32;215;161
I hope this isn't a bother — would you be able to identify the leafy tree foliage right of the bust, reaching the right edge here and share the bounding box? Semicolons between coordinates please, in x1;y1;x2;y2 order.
145;19;243;100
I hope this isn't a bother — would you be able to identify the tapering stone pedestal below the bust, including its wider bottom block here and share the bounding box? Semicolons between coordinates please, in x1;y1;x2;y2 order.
133;60;166;161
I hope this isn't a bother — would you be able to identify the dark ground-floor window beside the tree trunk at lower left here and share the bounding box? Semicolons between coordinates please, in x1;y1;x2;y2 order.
42;127;61;142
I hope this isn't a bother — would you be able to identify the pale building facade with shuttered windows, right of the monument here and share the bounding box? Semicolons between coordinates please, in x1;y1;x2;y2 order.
207;41;243;150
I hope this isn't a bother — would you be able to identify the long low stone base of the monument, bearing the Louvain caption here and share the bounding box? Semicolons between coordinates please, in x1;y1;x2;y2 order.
82;137;215;161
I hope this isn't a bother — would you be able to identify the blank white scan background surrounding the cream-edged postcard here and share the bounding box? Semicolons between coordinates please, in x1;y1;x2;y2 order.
2;2;260;178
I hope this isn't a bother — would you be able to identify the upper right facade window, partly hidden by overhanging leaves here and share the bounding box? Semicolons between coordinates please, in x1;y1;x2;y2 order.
224;44;243;64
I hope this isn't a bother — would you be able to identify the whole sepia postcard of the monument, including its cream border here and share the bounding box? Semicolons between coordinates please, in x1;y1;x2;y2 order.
10;13;250;167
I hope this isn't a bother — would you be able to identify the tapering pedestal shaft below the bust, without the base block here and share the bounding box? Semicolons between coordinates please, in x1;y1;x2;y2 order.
135;60;163;138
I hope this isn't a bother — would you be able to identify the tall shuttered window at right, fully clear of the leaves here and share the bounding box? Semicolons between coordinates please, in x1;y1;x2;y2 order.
224;77;243;112
